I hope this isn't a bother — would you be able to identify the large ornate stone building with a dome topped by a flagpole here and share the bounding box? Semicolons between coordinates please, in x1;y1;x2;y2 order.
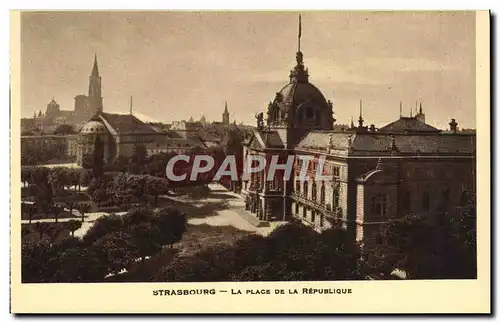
242;15;476;249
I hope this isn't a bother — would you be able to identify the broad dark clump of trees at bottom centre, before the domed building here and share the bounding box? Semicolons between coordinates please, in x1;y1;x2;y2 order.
156;223;361;281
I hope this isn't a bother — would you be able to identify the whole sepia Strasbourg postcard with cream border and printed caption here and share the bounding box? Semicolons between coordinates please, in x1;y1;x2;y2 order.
10;10;491;314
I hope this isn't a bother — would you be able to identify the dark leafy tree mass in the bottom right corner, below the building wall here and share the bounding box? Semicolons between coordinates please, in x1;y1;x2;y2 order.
368;208;476;279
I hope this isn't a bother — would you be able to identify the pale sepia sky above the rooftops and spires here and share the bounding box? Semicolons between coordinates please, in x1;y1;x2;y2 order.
21;11;475;128
